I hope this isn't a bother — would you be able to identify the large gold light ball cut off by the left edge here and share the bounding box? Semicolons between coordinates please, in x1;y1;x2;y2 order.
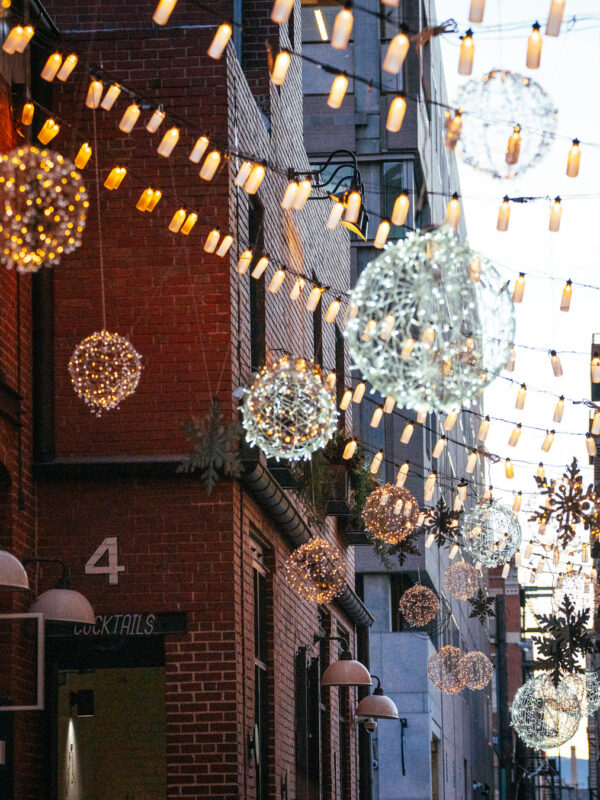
0;142;89;272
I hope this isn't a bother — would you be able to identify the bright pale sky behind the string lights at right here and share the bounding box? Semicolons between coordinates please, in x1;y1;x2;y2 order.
437;0;600;772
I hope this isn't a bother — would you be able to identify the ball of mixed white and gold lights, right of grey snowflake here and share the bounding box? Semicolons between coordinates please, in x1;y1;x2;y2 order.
242;356;338;461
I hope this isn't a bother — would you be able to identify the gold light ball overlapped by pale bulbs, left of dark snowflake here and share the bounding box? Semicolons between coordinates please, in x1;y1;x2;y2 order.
363;483;420;544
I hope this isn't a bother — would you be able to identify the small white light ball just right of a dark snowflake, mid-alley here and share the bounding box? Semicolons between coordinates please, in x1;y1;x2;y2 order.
462;500;521;567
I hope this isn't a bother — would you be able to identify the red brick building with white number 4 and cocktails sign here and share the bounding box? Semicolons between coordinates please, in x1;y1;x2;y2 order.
0;0;372;800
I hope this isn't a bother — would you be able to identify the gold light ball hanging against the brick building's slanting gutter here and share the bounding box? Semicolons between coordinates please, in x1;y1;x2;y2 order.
284;537;346;603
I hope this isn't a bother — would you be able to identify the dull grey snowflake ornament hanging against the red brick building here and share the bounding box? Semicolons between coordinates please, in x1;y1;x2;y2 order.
177;397;242;495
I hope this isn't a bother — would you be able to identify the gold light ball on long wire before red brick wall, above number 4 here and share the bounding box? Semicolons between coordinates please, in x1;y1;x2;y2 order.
69;330;142;417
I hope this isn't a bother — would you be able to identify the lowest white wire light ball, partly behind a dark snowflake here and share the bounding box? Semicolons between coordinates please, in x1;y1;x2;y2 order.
511;675;581;750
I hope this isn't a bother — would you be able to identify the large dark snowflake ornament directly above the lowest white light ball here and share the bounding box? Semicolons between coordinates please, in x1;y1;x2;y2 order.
533;595;594;686
